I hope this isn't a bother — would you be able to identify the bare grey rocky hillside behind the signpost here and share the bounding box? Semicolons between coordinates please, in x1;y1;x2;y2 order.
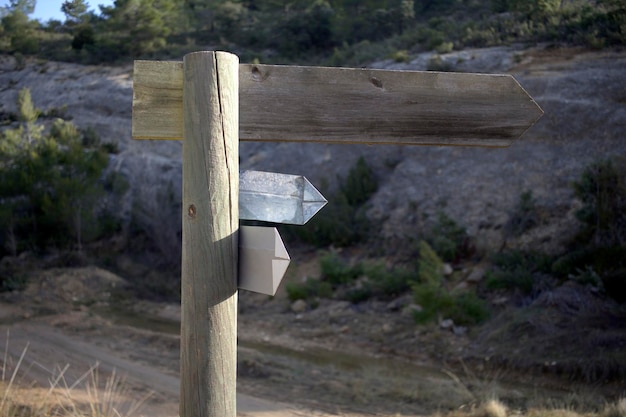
0;47;626;252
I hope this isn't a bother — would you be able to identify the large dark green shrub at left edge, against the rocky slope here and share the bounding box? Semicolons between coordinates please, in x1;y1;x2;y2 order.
0;89;108;254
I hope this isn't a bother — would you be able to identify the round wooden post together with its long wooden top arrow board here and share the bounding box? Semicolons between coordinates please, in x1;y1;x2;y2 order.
133;52;543;417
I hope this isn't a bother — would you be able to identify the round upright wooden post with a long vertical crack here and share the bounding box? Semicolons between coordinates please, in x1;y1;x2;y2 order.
180;52;239;417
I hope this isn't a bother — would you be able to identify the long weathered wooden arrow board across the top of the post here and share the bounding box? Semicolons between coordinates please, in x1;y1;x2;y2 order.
133;61;543;146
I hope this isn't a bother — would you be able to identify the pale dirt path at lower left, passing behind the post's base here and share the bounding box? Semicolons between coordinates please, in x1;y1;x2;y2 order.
0;321;338;417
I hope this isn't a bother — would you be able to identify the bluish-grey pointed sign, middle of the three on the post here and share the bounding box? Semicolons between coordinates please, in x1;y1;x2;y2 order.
239;171;327;225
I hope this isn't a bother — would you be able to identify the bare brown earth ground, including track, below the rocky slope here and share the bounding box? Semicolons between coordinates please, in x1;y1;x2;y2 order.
0;260;626;417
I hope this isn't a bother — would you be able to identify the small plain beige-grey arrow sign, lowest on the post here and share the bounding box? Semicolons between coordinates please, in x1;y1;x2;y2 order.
238;226;289;295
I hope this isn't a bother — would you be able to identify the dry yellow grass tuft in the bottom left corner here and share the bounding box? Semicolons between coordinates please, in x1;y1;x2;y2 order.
0;337;151;417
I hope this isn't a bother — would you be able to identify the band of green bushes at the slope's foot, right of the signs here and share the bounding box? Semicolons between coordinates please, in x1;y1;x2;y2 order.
286;153;626;342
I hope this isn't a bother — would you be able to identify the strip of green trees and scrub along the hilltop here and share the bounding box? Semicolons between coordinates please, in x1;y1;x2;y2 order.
0;0;626;65
